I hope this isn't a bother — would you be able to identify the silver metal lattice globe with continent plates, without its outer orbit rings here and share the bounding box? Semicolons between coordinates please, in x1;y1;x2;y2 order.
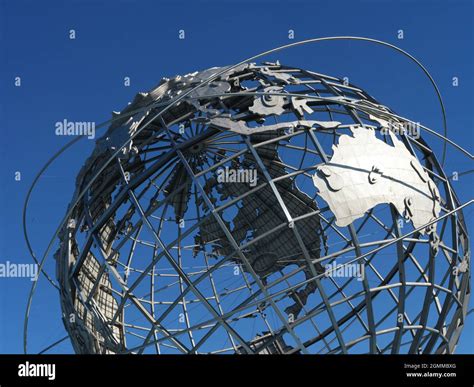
56;62;470;353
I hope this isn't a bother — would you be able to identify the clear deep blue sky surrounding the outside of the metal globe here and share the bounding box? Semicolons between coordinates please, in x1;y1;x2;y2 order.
0;0;474;353
